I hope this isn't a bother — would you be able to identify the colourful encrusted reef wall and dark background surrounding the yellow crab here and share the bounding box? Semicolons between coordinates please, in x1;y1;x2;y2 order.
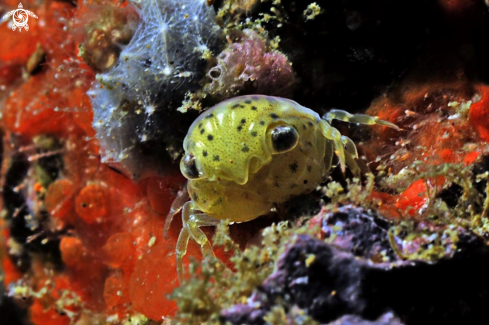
0;0;489;325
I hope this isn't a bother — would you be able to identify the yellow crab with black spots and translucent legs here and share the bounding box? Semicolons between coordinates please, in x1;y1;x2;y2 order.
164;95;399;283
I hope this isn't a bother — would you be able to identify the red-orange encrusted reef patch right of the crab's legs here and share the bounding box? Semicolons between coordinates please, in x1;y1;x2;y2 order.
360;82;488;218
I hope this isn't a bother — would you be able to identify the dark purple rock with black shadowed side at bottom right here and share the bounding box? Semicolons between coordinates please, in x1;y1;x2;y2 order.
221;211;489;324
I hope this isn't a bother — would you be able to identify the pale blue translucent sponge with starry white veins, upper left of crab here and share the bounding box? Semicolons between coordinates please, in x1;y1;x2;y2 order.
89;0;223;179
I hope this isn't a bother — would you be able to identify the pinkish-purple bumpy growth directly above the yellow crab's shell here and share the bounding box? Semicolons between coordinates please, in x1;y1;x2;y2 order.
208;29;295;97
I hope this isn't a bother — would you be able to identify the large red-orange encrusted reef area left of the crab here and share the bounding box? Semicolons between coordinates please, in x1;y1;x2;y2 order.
0;2;201;324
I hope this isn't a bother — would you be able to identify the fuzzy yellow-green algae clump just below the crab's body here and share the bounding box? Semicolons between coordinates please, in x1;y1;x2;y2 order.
171;222;291;324
